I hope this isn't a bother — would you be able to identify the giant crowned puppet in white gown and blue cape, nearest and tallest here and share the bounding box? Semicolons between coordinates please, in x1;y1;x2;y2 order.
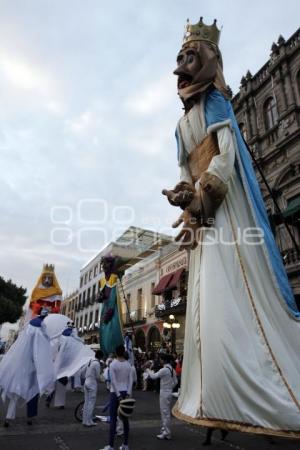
163;18;300;437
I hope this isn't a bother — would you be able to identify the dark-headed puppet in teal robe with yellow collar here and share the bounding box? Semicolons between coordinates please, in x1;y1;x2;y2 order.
99;255;124;356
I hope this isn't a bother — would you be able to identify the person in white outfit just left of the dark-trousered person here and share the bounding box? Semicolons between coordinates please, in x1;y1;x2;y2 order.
82;350;103;427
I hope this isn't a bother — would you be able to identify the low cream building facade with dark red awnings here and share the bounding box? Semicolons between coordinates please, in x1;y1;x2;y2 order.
122;243;188;352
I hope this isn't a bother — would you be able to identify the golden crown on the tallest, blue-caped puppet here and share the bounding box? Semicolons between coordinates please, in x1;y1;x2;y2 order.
182;17;221;45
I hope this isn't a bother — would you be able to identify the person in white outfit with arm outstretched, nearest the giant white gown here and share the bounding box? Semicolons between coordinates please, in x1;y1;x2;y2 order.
147;353;178;439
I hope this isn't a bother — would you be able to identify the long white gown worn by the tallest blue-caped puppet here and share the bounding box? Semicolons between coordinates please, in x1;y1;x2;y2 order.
174;96;300;437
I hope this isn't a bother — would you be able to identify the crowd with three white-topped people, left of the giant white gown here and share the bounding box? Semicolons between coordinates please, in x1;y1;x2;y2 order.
81;345;182;450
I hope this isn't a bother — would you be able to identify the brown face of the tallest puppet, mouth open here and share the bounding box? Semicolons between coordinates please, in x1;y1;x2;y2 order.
173;48;202;90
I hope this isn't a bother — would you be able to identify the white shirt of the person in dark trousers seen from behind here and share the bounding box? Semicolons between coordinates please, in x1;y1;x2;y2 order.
109;359;133;397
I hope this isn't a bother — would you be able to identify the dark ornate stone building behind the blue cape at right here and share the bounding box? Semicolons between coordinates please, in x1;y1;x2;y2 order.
232;29;300;306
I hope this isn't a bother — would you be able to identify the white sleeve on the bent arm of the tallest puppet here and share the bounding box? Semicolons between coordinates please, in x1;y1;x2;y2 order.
207;126;235;183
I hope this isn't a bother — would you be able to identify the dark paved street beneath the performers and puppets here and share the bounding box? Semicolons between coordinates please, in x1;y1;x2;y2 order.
0;385;300;450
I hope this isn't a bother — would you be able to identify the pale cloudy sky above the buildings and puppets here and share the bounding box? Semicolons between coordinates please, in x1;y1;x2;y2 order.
0;0;299;320
